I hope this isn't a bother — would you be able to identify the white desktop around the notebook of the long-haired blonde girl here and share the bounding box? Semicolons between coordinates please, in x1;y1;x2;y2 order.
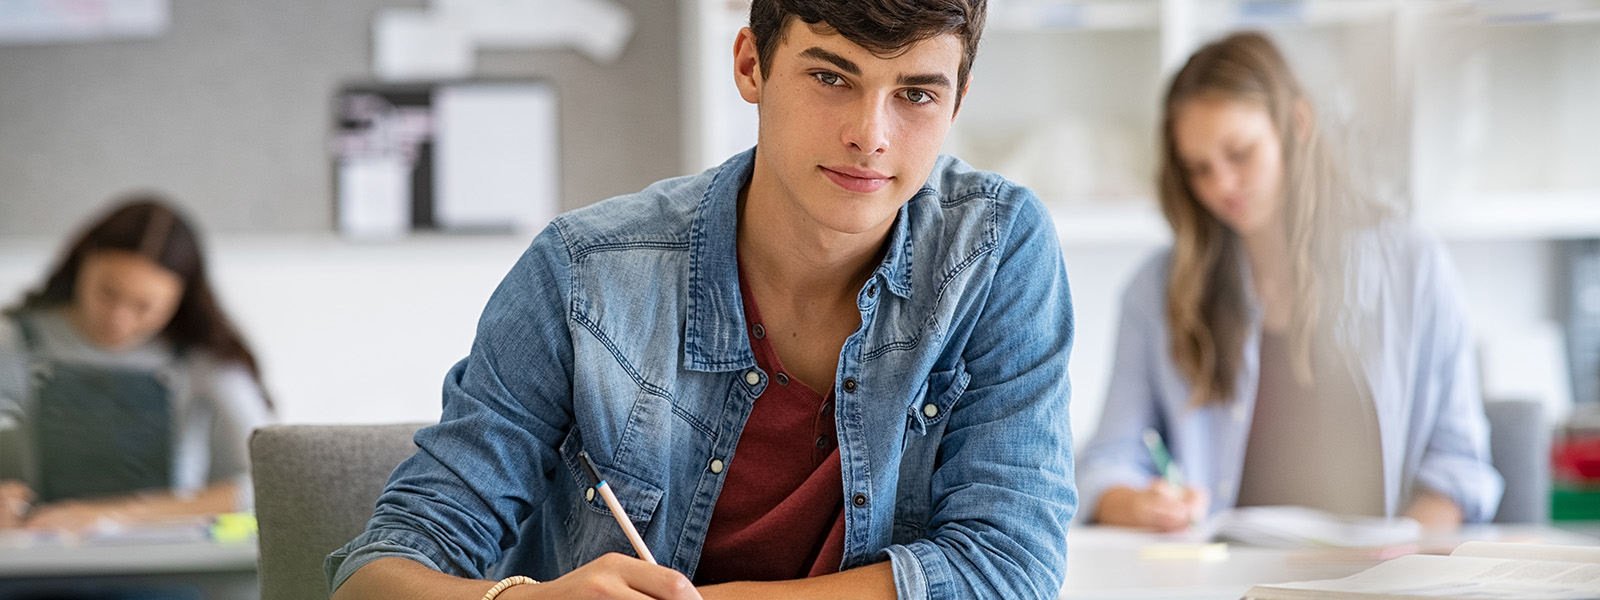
1061;525;1600;600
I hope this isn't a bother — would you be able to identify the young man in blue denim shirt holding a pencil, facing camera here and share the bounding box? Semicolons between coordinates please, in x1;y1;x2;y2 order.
328;0;1077;600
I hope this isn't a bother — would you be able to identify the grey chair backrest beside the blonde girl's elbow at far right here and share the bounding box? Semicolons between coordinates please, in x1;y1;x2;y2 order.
1483;400;1550;523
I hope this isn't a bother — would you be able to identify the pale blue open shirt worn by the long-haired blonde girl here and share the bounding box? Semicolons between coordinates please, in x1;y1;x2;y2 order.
1078;221;1502;522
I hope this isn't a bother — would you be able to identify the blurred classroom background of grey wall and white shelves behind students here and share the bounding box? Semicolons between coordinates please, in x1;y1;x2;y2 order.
0;0;1600;492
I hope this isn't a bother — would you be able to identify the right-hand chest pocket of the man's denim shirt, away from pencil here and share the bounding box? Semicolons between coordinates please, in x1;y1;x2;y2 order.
891;363;971;544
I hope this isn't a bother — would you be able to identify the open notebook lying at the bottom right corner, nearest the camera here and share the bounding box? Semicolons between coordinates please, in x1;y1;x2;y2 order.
1245;542;1600;600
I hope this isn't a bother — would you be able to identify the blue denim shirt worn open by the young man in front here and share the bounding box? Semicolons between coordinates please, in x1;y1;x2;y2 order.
326;150;1077;598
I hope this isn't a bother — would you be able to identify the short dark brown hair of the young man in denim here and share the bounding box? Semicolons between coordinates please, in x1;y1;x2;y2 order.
750;0;987;107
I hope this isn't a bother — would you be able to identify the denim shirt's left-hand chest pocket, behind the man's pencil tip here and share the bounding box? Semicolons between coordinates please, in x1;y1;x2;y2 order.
562;435;662;565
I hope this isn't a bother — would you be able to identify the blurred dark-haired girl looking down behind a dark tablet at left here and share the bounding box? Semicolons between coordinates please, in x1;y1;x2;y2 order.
0;197;270;531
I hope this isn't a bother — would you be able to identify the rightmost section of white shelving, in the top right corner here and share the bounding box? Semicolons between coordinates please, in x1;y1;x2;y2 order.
1411;0;1600;240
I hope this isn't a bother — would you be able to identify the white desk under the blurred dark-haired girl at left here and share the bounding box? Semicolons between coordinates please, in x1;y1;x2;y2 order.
0;538;259;600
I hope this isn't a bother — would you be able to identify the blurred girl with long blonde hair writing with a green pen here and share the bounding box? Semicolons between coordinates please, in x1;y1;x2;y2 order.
1078;34;1502;530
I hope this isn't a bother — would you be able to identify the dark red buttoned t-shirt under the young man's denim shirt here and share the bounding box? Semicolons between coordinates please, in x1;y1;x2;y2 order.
694;269;845;584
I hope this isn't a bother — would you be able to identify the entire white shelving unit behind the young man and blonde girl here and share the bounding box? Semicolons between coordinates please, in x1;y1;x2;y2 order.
685;0;1600;246
